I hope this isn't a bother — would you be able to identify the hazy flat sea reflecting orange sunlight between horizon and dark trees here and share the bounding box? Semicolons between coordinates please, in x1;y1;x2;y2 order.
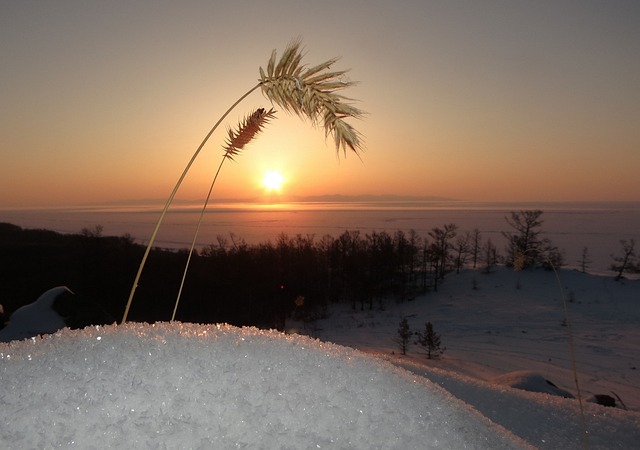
0;200;640;274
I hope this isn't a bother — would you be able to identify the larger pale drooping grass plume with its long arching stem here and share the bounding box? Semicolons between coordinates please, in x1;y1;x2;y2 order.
122;39;364;323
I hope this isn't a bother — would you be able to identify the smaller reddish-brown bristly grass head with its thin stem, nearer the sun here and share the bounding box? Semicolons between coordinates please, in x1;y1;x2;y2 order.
171;108;276;322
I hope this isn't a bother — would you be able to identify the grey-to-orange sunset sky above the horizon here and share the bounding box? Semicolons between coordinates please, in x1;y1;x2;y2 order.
0;0;640;208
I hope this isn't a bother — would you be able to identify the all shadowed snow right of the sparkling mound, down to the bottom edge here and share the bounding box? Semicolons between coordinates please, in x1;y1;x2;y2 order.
299;268;640;448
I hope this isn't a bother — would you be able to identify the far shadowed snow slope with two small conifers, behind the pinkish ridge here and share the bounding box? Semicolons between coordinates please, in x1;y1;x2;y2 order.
308;268;640;411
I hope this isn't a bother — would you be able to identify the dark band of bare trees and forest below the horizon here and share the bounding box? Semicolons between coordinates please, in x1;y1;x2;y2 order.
0;210;632;329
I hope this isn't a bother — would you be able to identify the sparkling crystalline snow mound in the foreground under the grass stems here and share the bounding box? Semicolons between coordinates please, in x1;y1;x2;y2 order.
0;323;526;449
